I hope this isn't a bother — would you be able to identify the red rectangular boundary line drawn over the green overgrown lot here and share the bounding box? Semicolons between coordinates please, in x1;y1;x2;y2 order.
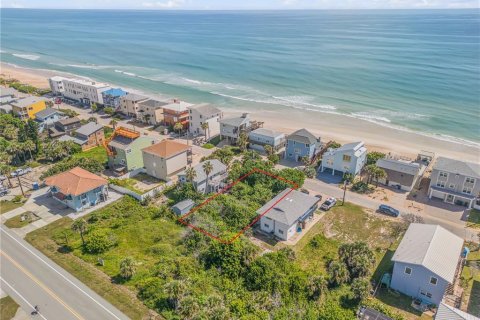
178;168;298;244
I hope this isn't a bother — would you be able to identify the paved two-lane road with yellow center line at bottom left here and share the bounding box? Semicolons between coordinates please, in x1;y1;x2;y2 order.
0;225;128;320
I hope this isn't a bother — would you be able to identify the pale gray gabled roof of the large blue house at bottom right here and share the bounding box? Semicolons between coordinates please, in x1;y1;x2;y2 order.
392;223;463;283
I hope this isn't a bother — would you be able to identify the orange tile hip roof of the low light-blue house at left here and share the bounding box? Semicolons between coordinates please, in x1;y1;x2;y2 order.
45;167;108;196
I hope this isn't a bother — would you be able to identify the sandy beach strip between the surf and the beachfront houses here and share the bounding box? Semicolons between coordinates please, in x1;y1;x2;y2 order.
0;62;480;163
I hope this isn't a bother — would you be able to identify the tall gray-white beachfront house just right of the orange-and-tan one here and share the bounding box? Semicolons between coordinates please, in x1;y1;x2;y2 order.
188;103;223;140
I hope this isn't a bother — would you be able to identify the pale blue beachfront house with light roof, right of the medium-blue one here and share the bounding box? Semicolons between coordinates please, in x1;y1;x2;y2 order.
320;141;367;176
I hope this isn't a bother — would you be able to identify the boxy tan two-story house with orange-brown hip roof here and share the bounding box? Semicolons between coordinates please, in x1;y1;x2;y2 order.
142;140;192;181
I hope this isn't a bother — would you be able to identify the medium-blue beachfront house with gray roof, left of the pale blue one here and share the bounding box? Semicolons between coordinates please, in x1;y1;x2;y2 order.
285;129;321;161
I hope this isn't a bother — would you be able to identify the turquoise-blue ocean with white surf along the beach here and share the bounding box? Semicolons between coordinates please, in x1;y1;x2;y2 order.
0;9;480;144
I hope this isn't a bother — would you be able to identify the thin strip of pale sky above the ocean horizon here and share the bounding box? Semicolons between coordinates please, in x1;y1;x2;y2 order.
0;0;480;10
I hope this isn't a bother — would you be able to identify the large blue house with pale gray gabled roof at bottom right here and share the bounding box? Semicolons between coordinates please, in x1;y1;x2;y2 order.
390;223;463;306
